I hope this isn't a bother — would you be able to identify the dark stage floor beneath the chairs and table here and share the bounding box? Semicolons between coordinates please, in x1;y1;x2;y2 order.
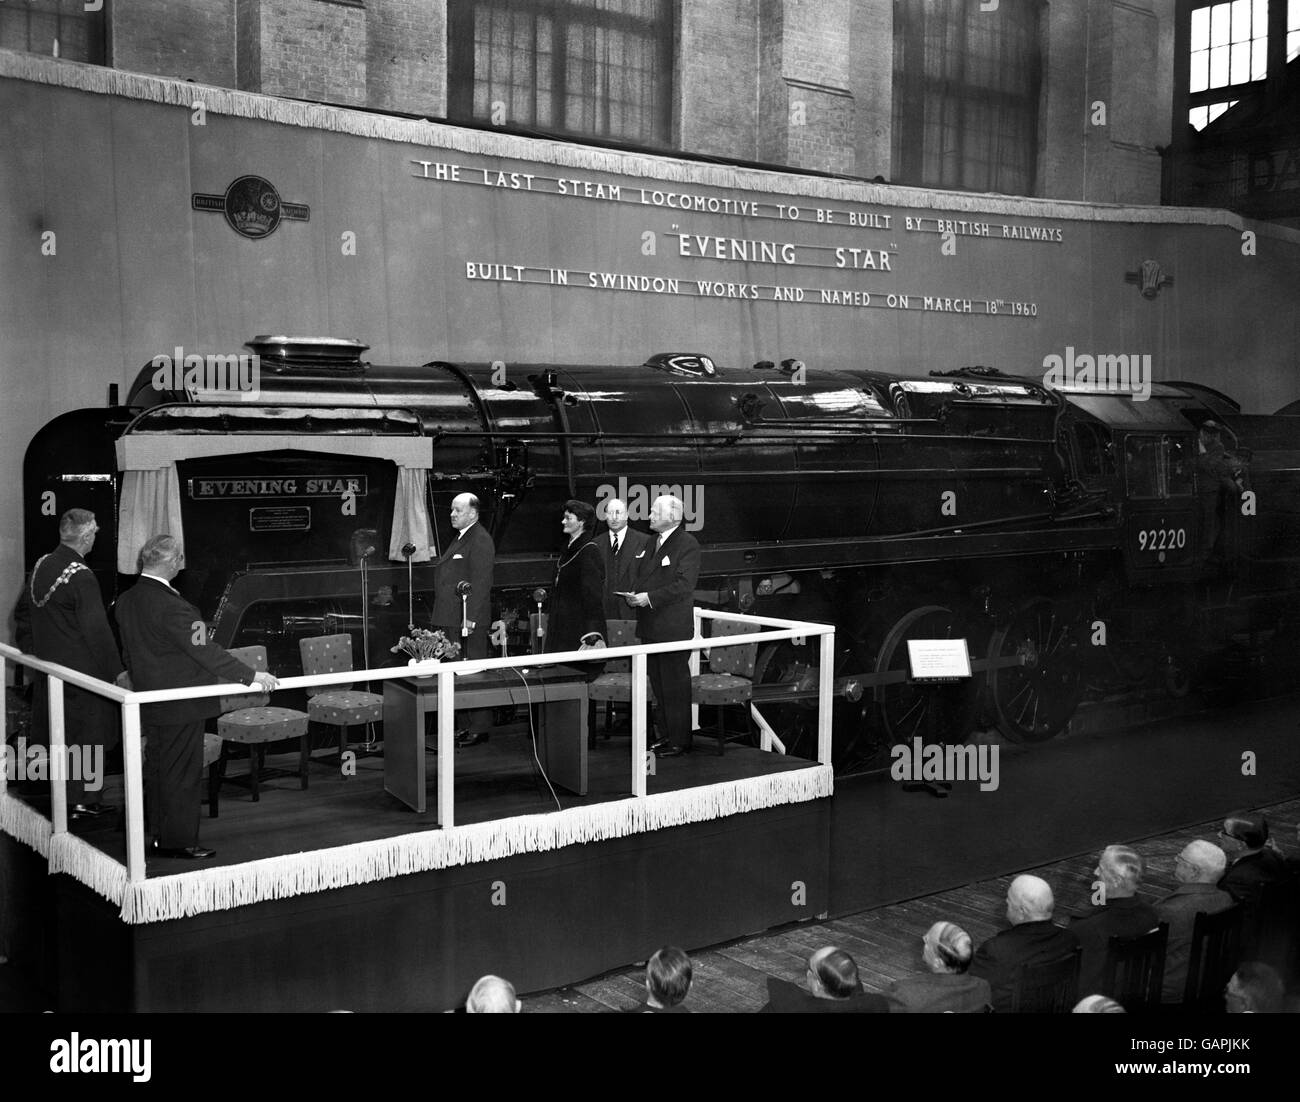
23;723;815;876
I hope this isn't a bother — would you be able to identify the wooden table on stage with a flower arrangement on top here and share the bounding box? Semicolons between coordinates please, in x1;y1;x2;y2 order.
384;665;588;825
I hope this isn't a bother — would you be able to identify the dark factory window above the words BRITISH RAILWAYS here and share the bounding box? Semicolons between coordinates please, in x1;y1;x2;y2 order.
893;0;1043;195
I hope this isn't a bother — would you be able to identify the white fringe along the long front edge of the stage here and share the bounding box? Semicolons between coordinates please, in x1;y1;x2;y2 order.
121;765;835;925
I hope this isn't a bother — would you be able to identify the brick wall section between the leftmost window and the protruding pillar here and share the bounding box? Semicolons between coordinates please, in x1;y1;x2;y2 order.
107;0;235;88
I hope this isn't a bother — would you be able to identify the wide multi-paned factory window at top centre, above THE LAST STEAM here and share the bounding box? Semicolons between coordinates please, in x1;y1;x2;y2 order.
447;0;673;147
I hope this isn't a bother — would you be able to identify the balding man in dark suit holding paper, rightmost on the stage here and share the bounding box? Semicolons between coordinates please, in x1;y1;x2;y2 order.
628;495;699;758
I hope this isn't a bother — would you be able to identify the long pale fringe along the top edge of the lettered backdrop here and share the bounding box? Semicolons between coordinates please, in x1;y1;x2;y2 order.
0;49;1300;240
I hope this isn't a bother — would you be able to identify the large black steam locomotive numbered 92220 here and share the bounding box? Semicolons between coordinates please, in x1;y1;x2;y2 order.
23;338;1300;760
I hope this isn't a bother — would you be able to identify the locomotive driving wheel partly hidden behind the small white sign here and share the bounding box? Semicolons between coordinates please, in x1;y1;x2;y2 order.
872;604;982;746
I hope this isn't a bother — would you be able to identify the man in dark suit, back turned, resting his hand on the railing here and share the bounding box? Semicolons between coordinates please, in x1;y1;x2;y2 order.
117;535;277;860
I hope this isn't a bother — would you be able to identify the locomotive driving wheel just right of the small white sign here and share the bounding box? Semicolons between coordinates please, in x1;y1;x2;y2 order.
988;596;1083;742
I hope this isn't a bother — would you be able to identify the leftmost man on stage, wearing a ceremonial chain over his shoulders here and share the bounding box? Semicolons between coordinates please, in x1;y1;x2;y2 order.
14;509;125;819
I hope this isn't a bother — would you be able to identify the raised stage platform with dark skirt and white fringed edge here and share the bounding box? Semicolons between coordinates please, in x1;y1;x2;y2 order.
3;732;829;1011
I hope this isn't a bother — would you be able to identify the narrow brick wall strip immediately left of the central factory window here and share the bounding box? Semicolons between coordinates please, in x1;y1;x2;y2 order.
365;0;447;117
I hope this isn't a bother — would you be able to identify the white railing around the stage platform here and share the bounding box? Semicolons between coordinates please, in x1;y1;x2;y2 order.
0;608;835;882
